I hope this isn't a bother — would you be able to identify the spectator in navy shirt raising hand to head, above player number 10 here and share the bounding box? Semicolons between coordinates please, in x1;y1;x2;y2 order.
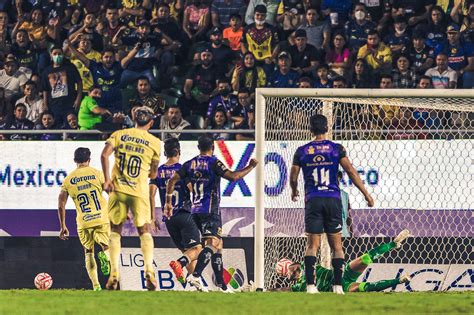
112;20;170;87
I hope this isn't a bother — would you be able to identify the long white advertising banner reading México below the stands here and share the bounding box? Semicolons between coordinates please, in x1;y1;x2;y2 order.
0;140;474;210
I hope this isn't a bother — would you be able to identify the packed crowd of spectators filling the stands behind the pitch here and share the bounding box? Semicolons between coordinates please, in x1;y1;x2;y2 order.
0;0;474;140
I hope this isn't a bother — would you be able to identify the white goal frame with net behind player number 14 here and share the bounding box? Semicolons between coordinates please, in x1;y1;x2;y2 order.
255;89;474;289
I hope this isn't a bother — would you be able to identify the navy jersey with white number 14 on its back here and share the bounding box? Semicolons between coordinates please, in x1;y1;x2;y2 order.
293;140;346;201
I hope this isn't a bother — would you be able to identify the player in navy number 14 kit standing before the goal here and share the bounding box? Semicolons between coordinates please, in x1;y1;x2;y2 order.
290;115;374;294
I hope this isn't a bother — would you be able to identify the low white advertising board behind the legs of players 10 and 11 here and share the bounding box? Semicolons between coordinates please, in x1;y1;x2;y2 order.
120;248;248;291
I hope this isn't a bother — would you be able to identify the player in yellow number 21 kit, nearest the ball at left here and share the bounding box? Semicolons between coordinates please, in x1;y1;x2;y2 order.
58;148;110;291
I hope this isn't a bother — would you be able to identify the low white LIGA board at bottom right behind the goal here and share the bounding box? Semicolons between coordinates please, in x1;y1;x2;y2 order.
358;264;474;292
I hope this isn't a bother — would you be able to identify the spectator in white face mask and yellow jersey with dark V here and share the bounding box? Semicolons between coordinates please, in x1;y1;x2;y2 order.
241;4;279;74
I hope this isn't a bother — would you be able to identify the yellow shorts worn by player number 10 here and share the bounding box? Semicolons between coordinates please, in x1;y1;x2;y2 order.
109;191;151;227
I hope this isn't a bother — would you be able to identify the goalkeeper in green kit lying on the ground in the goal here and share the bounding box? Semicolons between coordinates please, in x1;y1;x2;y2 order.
281;230;411;292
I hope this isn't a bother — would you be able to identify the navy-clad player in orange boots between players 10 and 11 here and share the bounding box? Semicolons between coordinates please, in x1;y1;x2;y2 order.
150;138;202;283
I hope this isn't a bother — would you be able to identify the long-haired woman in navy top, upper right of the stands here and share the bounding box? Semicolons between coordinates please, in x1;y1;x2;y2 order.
415;6;448;48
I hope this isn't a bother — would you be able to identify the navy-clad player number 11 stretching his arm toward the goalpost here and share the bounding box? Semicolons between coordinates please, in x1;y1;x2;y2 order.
165;136;257;293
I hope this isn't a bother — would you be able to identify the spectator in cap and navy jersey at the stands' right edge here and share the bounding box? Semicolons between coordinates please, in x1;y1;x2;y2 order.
437;24;474;89
